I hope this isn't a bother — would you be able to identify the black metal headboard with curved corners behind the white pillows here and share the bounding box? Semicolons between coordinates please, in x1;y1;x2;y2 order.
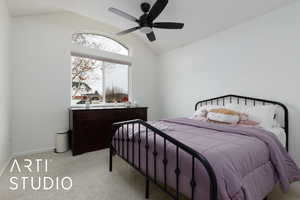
195;94;289;150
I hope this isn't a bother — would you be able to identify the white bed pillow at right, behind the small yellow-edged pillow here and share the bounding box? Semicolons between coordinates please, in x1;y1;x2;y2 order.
226;104;277;128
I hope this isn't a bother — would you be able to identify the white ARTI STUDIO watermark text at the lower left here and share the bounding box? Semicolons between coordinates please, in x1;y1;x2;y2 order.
9;159;73;191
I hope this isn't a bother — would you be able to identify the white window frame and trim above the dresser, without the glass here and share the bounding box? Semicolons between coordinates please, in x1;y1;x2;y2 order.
70;32;132;108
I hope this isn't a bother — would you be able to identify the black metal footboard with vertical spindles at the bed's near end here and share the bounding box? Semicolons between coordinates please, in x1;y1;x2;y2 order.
109;120;218;200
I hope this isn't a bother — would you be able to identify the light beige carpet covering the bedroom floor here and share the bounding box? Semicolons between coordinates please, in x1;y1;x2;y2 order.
0;150;300;200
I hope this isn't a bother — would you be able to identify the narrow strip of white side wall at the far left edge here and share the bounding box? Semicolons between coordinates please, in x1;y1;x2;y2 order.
0;0;11;175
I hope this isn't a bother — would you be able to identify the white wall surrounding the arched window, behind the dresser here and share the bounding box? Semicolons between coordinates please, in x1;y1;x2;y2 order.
12;13;158;154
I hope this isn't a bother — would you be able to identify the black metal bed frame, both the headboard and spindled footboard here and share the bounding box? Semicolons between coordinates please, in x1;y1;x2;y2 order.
109;95;289;200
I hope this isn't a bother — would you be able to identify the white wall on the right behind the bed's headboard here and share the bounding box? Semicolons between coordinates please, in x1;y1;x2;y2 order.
160;3;300;164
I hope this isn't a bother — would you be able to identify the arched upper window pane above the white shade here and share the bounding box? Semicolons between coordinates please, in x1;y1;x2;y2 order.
72;33;129;56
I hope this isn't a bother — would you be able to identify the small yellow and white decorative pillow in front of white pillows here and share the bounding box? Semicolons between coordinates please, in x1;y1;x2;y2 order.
207;108;240;124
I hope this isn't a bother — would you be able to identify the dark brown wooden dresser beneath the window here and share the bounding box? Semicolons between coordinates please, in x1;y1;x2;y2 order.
70;107;147;156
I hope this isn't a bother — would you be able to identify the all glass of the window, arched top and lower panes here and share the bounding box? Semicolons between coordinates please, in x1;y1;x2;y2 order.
71;33;129;106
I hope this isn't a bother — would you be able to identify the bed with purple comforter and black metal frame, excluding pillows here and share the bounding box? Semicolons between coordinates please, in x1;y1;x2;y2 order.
109;95;300;200
